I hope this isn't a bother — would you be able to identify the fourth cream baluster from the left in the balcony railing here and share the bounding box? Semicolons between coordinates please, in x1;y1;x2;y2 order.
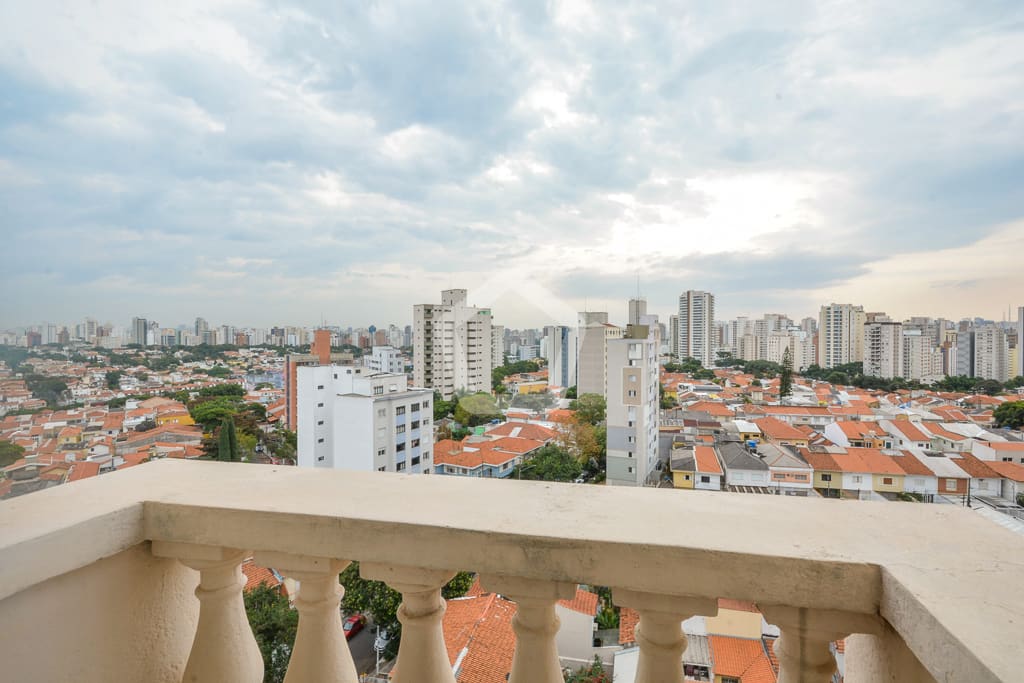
480;577;575;683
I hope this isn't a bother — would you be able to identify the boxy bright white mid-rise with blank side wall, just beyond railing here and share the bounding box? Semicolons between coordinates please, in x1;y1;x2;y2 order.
296;365;434;474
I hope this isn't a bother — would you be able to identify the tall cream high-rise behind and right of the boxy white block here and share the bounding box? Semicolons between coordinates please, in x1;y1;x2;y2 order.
413;290;494;400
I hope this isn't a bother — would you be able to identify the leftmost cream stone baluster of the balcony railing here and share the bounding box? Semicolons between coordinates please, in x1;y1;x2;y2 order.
153;541;263;683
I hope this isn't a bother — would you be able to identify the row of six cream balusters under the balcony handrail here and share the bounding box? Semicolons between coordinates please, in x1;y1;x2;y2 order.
153;542;884;683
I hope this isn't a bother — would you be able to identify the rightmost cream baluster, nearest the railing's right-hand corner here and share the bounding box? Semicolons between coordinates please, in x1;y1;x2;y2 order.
759;605;880;683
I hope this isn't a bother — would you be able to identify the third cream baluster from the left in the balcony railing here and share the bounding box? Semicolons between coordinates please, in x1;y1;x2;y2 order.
359;562;456;683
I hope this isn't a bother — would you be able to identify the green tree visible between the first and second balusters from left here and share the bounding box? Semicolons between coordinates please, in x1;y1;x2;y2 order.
244;584;299;683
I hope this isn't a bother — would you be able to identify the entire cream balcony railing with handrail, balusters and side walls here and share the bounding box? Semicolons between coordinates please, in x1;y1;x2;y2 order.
0;461;1024;683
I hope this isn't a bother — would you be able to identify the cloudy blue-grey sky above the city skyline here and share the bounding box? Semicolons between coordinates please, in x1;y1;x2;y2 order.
0;0;1024;329
